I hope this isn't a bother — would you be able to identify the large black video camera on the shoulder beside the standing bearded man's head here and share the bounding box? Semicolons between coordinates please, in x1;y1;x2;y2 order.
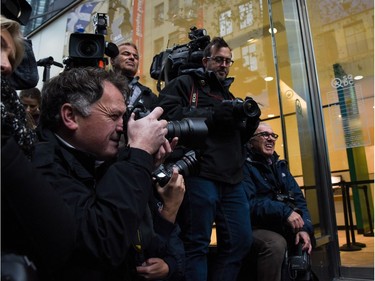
150;26;211;91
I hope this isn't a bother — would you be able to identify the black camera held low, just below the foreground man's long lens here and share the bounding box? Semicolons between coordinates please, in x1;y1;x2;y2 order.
152;150;199;187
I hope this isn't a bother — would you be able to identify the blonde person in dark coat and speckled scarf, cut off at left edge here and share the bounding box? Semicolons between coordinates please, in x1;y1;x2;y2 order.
0;15;76;280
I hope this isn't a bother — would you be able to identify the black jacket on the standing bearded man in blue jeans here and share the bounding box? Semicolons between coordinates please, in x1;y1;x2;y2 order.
159;69;258;184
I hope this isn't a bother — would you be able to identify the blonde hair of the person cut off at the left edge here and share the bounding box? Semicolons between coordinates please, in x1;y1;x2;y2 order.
0;15;25;70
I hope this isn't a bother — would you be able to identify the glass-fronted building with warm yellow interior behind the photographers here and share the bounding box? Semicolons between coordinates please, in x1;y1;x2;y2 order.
28;0;374;280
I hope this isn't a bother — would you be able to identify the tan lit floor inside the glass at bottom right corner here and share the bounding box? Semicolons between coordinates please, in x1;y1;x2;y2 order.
338;230;374;267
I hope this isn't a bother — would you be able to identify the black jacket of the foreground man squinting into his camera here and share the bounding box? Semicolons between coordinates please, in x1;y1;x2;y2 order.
33;130;183;280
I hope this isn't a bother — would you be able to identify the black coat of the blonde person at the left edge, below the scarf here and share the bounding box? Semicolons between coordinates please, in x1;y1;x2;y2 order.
1;137;76;280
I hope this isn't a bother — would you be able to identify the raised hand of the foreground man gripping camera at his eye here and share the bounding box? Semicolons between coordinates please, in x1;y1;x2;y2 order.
127;107;168;155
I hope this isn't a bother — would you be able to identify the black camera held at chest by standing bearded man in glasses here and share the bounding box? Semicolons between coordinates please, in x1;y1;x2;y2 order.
222;97;261;119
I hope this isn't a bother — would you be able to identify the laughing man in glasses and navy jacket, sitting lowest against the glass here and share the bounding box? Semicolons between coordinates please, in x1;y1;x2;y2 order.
244;122;313;281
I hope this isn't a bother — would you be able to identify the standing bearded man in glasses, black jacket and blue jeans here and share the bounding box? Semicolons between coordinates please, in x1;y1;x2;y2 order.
159;37;260;281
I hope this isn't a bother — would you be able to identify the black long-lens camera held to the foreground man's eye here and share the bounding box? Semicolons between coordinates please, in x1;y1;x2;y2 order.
124;102;208;148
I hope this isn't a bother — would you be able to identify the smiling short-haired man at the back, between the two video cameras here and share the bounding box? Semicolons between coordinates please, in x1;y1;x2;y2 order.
111;42;157;110
